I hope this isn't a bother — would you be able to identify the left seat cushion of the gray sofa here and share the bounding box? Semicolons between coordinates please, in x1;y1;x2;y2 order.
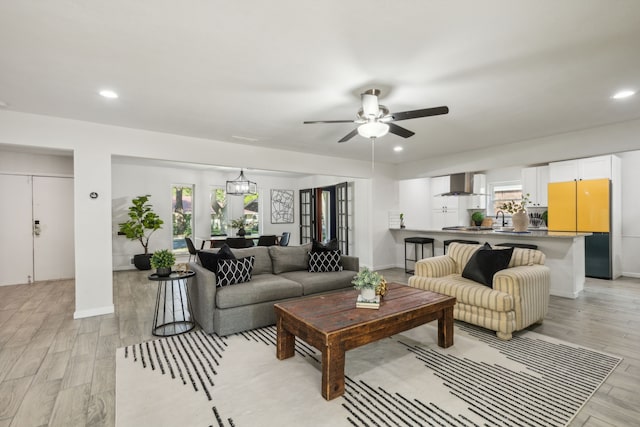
215;273;309;308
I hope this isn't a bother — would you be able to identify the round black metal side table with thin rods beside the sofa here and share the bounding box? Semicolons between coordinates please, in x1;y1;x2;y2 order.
149;270;196;337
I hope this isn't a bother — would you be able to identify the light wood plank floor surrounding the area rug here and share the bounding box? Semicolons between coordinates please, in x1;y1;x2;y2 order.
0;269;640;427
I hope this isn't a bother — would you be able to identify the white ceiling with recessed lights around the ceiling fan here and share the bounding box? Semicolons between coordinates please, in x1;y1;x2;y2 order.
0;0;640;163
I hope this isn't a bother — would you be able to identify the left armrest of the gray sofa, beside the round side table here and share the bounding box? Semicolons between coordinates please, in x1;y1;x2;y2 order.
189;262;216;334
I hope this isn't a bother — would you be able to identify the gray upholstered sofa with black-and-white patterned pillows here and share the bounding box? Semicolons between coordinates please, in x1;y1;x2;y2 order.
189;244;359;336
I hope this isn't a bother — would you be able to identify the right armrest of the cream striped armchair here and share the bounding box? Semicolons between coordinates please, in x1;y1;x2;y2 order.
493;264;551;330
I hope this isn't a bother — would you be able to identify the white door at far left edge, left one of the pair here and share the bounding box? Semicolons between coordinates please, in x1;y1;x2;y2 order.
0;174;33;285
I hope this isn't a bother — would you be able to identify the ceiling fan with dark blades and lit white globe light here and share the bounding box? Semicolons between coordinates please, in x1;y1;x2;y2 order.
304;89;449;142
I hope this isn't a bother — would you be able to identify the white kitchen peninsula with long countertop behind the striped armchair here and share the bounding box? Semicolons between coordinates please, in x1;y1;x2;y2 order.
390;228;591;298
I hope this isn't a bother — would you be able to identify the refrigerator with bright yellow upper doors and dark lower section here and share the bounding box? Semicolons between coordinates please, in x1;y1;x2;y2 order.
547;179;612;279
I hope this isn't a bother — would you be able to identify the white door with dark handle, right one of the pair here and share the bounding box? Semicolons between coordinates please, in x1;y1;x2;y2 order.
33;177;75;281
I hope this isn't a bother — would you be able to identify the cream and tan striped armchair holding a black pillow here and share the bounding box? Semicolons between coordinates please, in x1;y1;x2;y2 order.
409;243;550;340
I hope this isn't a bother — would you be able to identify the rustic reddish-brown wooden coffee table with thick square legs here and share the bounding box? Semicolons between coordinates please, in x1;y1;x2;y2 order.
274;283;456;400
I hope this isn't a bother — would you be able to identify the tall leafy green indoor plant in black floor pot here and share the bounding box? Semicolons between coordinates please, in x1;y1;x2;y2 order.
119;194;164;270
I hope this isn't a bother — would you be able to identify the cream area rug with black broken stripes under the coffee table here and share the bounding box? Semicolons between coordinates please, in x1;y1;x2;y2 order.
116;322;621;427
